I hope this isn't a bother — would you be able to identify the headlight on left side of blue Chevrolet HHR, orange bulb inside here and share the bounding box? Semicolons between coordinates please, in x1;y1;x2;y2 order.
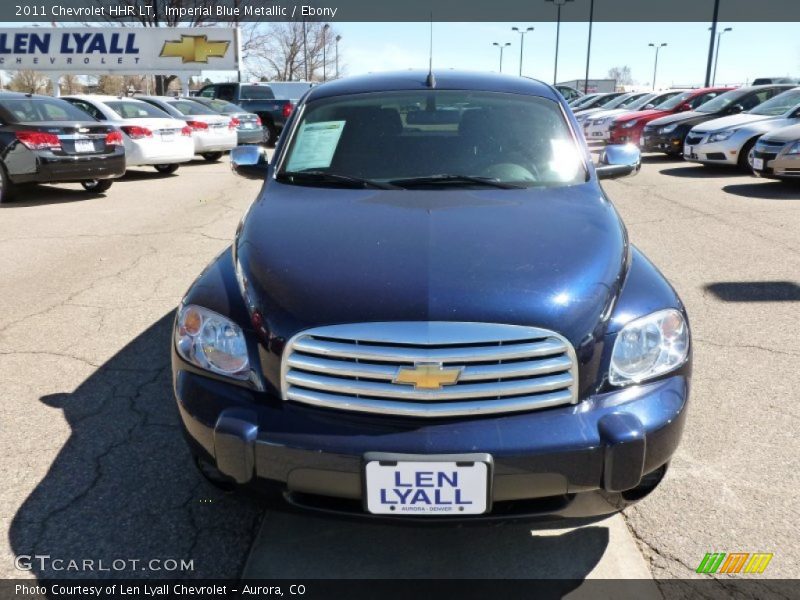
175;304;250;380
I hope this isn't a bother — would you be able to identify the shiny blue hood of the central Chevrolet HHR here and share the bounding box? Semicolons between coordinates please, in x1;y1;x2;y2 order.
235;180;628;347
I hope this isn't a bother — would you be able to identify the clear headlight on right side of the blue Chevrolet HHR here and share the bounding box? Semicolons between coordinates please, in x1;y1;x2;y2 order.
608;308;689;385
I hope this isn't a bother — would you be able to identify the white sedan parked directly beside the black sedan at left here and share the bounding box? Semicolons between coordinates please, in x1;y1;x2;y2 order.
62;94;194;173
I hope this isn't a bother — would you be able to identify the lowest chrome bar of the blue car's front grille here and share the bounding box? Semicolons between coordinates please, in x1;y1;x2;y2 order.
287;388;572;417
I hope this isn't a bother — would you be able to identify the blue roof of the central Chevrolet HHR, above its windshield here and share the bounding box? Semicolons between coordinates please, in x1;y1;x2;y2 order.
306;70;561;102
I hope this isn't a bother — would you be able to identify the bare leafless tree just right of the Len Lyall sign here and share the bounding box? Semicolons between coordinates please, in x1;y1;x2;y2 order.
242;21;341;81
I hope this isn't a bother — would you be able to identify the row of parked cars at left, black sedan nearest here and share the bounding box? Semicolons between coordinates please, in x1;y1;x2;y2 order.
0;92;266;202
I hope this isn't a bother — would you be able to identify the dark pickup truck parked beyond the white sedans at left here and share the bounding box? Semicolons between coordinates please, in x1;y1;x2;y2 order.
197;83;294;146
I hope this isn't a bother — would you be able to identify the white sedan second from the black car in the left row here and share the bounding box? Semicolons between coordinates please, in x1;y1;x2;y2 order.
136;96;237;162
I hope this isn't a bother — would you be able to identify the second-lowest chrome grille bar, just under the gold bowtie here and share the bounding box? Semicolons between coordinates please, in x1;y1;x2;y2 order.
286;370;573;401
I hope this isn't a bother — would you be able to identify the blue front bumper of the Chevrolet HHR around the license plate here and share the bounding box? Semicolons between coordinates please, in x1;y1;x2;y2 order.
174;366;689;520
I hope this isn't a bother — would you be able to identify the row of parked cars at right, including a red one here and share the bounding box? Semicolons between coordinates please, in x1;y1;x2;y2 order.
573;83;800;179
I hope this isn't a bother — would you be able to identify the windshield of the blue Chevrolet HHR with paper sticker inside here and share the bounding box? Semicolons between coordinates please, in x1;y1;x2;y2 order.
278;90;586;189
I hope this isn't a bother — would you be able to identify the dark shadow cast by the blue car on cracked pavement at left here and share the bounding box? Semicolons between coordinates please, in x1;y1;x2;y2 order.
9;313;262;579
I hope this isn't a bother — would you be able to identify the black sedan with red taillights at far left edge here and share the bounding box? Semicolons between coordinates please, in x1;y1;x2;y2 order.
0;92;125;202
